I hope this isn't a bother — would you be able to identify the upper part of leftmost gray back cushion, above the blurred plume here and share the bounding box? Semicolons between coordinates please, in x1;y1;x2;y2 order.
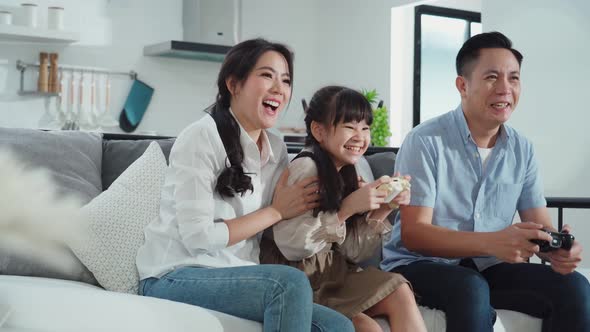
0;128;102;203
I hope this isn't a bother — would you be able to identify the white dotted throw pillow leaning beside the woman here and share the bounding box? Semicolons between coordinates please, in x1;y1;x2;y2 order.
72;142;167;294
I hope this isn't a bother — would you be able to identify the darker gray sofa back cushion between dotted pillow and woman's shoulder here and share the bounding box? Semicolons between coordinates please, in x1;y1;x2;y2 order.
102;138;174;190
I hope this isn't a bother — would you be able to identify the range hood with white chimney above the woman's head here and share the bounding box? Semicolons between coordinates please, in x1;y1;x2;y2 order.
143;0;241;62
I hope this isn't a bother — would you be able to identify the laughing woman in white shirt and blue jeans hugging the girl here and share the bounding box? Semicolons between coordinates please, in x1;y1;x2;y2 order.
137;39;353;331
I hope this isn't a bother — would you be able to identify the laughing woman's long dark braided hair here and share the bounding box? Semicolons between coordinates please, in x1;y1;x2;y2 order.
207;38;293;197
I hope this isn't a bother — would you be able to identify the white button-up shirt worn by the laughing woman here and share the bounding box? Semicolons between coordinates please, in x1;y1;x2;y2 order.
136;114;288;280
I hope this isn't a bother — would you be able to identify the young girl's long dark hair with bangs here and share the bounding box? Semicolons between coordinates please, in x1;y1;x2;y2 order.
305;86;373;231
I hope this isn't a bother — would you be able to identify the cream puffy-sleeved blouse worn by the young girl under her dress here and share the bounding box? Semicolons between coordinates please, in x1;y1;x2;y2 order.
273;157;391;263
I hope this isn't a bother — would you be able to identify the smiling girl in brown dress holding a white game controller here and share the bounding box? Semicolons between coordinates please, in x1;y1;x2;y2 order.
261;86;426;332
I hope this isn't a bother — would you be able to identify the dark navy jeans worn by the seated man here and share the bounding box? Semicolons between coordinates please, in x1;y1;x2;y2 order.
393;260;590;332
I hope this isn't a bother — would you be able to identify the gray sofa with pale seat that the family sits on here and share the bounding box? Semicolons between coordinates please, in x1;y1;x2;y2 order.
0;128;564;332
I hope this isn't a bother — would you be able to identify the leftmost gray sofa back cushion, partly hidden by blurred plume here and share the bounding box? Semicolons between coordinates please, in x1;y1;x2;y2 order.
0;128;102;284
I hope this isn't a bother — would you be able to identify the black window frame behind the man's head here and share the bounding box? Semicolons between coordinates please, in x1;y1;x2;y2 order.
412;5;481;127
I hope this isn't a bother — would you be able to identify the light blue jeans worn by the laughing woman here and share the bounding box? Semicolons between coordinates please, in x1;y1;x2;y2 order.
139;265;354;332
